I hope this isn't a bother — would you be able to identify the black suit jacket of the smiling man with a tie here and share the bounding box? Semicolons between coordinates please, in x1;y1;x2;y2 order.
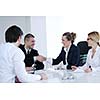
19;44;44;70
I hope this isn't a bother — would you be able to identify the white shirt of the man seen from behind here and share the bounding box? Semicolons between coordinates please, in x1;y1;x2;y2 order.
0;43;41;83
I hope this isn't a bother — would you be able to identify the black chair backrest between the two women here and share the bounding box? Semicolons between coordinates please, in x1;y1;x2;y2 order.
77;41;91;66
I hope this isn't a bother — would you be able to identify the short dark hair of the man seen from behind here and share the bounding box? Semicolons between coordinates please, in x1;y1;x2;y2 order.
5;25;23;43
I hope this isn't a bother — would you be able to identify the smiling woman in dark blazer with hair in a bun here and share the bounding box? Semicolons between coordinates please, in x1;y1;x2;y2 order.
52;32;80;69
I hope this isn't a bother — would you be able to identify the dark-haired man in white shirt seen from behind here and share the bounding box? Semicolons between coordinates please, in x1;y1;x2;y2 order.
0;25;47;83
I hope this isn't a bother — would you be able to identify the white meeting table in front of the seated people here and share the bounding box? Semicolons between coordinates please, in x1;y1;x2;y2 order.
31;68;100;83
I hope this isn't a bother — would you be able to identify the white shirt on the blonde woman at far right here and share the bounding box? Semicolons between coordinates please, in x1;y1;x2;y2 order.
79;46;100;71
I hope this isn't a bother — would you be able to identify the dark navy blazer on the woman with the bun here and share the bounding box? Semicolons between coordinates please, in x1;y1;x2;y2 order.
52;44;80;69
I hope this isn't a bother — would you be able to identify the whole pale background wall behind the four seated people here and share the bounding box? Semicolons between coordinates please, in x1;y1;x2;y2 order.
0;15;100;58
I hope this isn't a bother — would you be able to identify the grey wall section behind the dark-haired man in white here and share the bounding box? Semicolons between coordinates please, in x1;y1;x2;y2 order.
0;16;30;43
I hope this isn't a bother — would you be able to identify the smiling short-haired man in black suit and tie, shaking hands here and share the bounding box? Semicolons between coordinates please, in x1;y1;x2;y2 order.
19;34;46;71
